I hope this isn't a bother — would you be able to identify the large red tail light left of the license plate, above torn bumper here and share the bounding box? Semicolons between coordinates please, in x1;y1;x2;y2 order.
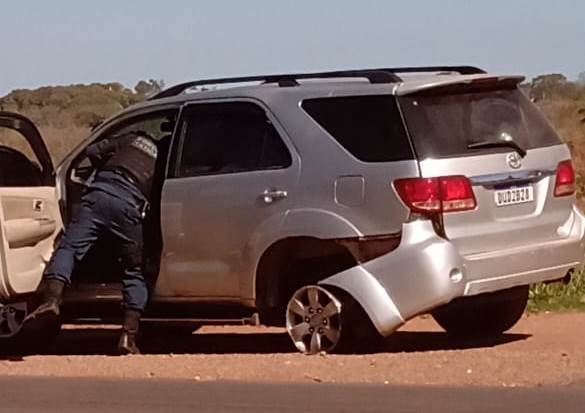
394;175;477;213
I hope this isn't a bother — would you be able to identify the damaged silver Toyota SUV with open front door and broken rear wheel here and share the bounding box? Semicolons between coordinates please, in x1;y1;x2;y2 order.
0;67;585;353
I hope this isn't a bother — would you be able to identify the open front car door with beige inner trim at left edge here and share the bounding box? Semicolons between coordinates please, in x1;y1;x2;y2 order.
0;111;62;301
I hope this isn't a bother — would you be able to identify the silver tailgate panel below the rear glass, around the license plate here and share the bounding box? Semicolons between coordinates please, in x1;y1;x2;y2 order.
420;145;575;255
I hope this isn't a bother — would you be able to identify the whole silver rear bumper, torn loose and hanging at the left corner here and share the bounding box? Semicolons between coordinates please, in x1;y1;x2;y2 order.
319;208;585;336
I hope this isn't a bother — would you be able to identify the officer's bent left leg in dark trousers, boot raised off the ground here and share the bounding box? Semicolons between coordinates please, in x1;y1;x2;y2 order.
25;191;104;321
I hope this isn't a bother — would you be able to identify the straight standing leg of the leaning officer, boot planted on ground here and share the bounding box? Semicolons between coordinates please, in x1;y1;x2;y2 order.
110;192;148;354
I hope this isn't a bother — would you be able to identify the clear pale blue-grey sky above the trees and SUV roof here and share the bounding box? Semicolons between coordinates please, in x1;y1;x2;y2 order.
0;0;585;96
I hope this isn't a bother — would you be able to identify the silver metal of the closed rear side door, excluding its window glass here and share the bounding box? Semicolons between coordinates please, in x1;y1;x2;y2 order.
154;99;301;299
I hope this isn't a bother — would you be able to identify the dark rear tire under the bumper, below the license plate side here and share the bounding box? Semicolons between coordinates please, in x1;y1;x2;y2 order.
432;285;529;338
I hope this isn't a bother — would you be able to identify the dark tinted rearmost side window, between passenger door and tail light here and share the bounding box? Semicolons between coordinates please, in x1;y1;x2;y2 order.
302;95;414;162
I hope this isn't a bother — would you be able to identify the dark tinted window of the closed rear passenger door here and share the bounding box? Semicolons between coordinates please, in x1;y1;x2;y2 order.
179;102;291;176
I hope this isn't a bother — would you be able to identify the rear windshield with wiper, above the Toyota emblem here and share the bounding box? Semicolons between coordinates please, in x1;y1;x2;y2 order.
399;88;560;158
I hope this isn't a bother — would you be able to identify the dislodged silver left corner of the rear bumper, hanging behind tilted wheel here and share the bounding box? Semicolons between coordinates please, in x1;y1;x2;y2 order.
319;220;466;336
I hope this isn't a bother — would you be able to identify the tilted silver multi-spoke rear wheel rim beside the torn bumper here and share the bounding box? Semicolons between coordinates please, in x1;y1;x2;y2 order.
286;285;341;354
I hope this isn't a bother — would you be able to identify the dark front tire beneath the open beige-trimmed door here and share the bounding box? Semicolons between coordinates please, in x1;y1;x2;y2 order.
0;300;61;355
